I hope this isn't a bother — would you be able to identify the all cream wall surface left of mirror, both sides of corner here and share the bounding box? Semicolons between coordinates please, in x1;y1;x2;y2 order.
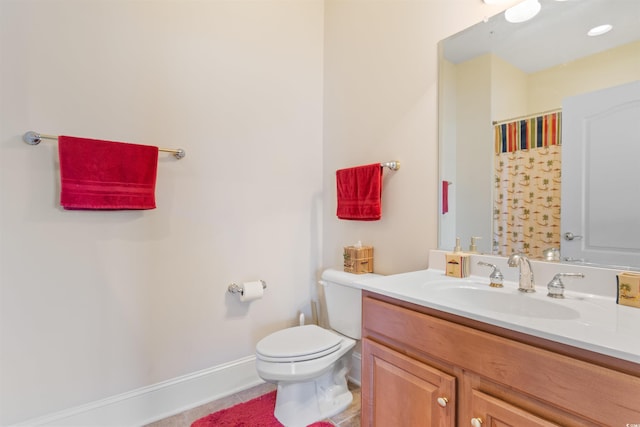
0;0;508;425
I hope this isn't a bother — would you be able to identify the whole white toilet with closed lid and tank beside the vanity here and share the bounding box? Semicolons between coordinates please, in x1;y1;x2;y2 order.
256;270;377;427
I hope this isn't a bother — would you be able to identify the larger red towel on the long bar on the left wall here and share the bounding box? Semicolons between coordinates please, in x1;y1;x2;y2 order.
58;136;158;210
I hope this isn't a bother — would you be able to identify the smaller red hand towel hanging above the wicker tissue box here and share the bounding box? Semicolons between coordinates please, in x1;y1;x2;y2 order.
336;163;382;221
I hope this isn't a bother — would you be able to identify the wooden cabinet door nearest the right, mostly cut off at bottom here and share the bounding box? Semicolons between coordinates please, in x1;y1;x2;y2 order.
470;390;558;427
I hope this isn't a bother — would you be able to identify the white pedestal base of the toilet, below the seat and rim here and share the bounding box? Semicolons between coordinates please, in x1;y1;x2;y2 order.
274;358;353;427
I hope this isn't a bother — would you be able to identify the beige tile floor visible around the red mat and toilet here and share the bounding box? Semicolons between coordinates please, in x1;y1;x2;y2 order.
145;383;360;427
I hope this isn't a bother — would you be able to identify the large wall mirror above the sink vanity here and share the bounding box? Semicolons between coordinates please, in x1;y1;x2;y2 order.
438;0;640;268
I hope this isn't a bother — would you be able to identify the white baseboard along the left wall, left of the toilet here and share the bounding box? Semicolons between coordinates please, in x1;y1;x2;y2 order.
14;356;264;427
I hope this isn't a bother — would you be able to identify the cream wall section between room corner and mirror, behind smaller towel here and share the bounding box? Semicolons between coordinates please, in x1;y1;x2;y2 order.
323;0;497;274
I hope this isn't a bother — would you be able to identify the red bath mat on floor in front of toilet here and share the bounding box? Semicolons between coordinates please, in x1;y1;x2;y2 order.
191;390;333;427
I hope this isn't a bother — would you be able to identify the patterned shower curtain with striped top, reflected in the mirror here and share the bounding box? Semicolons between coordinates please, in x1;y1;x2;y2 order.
493;112;562;258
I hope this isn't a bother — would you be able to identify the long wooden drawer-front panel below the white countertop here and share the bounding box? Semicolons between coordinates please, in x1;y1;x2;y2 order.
363;296;640;426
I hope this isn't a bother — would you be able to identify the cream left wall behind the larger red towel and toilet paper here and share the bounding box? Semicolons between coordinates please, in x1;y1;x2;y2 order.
0;0;324;425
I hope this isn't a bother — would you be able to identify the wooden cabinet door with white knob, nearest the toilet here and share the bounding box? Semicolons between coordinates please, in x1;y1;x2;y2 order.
361;338;456;427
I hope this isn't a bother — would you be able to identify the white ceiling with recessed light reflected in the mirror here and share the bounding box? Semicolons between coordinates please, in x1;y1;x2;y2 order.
443;0;640;73
